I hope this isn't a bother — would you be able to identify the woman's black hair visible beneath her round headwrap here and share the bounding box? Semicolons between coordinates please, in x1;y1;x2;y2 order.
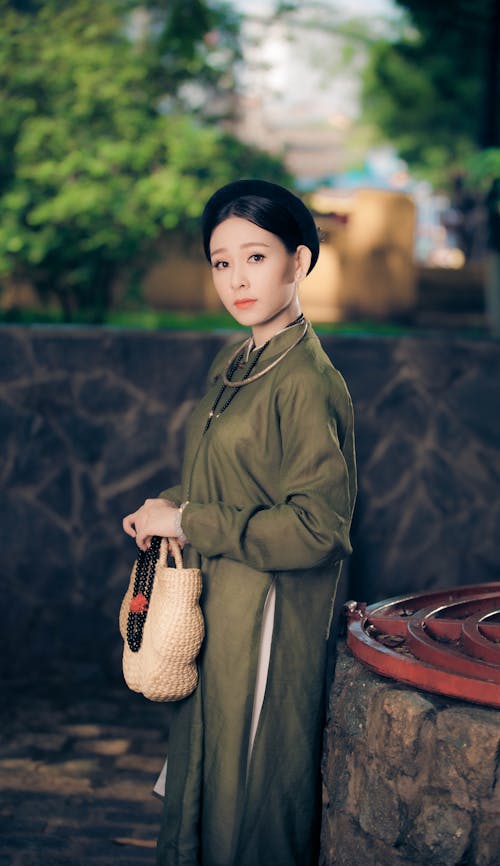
210;195;303;253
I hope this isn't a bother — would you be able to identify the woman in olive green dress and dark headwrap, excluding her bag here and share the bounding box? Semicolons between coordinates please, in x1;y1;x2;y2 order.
124;180;356;866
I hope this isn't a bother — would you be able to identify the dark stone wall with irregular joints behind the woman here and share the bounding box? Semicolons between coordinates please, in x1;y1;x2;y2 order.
0;327;500;673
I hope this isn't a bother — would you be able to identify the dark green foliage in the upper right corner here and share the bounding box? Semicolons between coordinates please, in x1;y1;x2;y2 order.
363;0;499;181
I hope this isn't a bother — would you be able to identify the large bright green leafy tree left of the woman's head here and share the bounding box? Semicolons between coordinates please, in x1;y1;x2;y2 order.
0;0;286;321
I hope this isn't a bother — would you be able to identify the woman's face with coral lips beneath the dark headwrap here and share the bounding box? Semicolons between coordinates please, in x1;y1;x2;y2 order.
210;216;310;345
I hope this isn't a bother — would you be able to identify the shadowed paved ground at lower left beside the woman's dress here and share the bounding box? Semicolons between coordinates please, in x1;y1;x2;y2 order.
0;668;172;866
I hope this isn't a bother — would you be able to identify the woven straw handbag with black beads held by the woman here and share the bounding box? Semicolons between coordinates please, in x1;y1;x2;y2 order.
120;536;205;701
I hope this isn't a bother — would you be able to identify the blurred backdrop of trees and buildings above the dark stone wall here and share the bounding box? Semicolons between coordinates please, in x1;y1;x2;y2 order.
0;0;500;334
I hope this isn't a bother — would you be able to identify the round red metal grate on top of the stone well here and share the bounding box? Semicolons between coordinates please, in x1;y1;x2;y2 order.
345;583;500;707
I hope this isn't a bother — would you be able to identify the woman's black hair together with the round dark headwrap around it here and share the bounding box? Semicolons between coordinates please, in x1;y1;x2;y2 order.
201;180;319;273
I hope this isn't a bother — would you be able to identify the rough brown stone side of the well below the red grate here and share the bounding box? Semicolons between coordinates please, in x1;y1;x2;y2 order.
322;643;500;866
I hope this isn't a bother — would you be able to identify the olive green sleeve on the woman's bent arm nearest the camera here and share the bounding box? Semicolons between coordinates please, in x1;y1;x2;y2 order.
182;369;356;571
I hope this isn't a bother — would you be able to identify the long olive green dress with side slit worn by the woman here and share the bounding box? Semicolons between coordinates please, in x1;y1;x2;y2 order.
158;325;356;866
